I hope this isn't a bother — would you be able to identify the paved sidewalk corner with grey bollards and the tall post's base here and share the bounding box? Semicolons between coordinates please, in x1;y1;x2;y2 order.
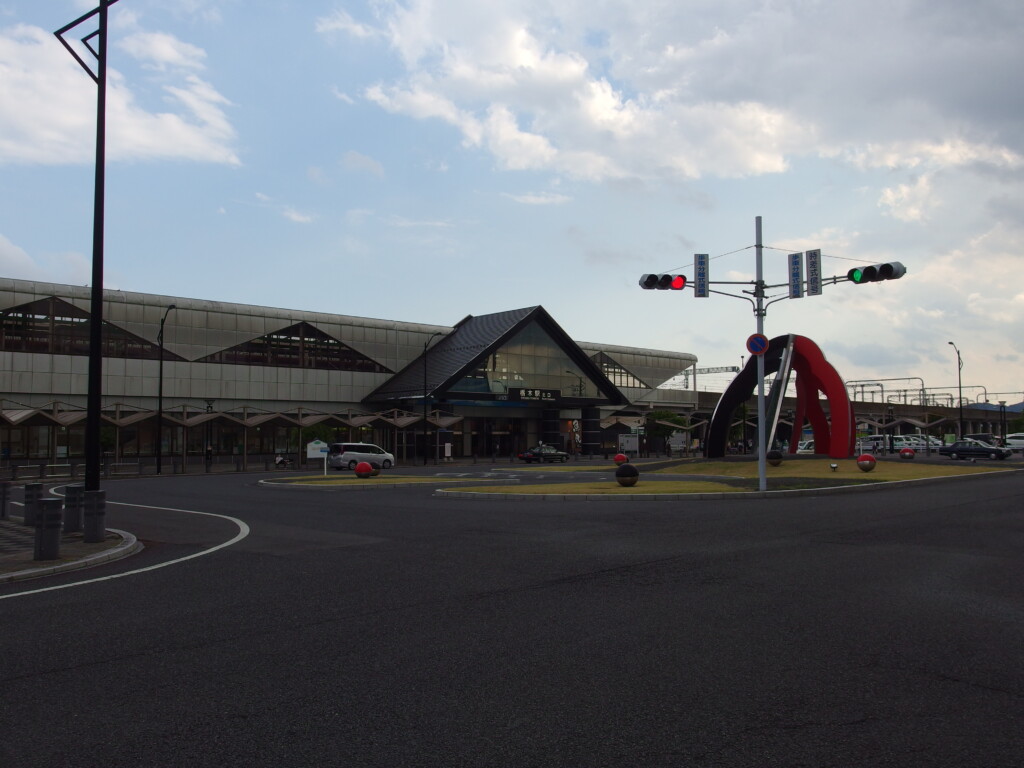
0;515;142;584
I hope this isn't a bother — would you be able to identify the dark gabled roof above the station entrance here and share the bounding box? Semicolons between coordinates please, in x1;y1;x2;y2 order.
365;306;626;404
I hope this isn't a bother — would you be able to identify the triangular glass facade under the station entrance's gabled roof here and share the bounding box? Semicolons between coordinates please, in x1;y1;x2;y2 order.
450;324;601;398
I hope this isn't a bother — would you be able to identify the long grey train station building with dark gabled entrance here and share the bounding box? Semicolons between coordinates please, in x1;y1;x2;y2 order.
0;279;697;469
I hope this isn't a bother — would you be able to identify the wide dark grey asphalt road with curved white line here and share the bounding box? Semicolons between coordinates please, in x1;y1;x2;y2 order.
0;473;1024;768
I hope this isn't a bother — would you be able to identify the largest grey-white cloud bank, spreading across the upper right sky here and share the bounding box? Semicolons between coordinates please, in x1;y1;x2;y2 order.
322;0;1024;189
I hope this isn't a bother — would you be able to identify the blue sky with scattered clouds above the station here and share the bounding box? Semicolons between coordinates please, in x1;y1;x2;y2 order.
0;0;1024;403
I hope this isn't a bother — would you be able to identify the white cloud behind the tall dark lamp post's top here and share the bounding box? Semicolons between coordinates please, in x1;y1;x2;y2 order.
0;25;240;165
